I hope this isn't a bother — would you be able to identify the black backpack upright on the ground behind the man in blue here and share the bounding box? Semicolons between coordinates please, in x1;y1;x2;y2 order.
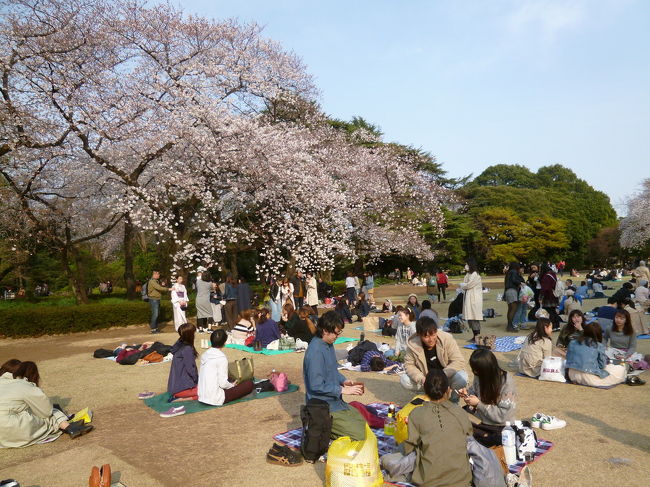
300;399;332;462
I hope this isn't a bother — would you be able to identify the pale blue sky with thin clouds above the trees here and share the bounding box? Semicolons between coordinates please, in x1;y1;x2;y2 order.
172;0;650;214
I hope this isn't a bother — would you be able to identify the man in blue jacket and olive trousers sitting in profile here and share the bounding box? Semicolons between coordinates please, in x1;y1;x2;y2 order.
303;311;366;441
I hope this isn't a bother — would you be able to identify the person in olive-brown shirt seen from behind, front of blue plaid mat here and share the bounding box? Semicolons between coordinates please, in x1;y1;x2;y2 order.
404;369;472;487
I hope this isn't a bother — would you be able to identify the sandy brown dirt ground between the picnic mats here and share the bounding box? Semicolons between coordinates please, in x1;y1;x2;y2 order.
0;278;650;487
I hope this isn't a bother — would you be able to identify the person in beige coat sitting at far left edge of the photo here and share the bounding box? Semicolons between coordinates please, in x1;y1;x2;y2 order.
0;359;93;448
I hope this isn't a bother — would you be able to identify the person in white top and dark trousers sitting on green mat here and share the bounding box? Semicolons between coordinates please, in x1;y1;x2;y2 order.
198;330;253;406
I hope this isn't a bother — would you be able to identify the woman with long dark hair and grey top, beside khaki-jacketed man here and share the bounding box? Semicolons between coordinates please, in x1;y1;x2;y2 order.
459;349;517;426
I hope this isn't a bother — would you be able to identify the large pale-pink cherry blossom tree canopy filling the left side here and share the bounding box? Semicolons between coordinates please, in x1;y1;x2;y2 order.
0;0;451;295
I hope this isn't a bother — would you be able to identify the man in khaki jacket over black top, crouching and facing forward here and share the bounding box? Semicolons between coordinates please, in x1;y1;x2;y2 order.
400;317;467;402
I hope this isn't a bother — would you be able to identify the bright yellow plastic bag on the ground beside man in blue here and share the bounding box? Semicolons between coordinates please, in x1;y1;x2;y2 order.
325;425;384;487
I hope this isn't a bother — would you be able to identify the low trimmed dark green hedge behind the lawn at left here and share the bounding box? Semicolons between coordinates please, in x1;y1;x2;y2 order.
0;301;196;338
